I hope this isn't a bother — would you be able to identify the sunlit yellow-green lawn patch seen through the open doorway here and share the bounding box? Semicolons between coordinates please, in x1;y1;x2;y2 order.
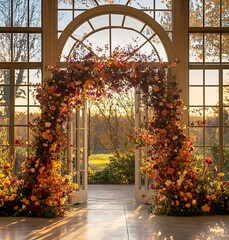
88;154;113;172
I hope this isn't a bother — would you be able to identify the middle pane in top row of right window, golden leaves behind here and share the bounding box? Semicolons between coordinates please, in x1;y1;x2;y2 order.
204;0;220;27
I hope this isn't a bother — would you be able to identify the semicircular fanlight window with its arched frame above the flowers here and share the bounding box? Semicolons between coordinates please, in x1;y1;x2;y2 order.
59;6;171;62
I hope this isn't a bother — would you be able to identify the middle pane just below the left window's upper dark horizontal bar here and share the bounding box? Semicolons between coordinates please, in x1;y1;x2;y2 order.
13;33;28;62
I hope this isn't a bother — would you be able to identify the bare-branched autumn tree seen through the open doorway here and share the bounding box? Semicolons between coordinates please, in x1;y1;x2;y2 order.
90;91;134;156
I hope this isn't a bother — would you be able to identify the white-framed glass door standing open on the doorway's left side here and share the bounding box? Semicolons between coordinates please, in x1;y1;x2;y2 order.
68;102;88;204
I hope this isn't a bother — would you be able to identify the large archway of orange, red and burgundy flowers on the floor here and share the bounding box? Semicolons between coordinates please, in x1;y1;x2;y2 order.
0;51;228;217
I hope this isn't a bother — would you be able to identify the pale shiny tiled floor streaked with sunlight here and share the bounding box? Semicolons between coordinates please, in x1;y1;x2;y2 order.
0;185;229;240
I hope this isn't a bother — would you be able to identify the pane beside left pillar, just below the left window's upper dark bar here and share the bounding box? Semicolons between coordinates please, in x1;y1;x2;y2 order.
29;33;41;62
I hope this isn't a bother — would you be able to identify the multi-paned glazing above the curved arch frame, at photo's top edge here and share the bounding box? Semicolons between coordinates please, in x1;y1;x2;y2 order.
58;0;172;38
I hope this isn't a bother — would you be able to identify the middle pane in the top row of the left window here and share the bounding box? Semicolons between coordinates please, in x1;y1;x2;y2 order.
13;0;28;27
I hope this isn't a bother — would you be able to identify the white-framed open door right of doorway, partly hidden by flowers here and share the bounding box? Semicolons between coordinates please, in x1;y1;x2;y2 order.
135;88;154;202
